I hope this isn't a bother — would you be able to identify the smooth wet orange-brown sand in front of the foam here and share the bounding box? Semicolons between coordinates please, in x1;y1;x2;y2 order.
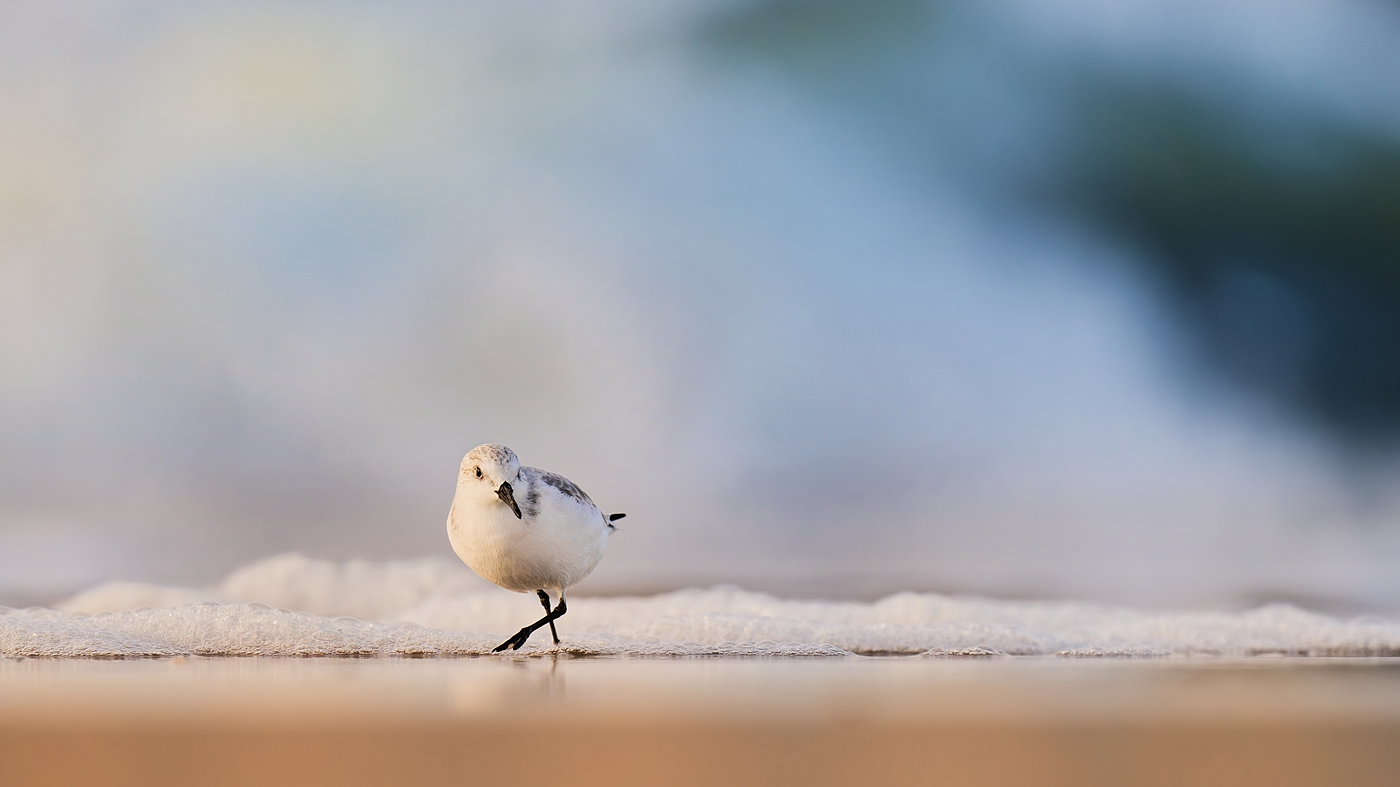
0;657;1400;787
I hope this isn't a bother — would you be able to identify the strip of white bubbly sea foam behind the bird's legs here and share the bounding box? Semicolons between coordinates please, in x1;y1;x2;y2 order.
0;555;1400;658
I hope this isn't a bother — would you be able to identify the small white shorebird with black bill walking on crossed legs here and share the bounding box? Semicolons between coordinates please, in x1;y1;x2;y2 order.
447;444;626;651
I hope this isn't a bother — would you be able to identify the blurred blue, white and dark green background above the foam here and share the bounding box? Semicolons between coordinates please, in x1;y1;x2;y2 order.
0;0;1400;612
